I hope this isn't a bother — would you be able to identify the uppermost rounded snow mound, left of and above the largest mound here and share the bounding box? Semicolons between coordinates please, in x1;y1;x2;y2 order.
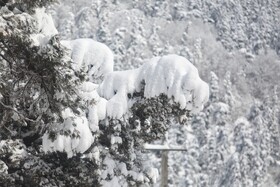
61;38;114;82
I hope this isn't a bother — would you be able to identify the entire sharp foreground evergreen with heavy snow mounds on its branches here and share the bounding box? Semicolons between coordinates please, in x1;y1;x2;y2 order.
0;1;209;186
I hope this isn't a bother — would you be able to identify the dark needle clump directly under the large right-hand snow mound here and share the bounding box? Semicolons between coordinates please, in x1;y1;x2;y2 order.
129;94;190;142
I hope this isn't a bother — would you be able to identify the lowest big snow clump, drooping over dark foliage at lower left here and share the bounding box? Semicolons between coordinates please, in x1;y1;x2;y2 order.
43;109;94;157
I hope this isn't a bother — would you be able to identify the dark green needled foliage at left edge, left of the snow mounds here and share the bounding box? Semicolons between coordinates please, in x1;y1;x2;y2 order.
0;4;83;138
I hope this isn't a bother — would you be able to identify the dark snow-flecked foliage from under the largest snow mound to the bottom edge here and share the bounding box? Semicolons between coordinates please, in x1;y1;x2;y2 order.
97;90;190;186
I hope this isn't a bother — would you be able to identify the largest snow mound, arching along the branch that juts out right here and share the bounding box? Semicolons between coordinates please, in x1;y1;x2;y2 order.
98;55;209;118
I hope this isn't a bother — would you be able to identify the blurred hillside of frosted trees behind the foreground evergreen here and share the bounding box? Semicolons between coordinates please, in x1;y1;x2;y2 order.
49;0;280;186
